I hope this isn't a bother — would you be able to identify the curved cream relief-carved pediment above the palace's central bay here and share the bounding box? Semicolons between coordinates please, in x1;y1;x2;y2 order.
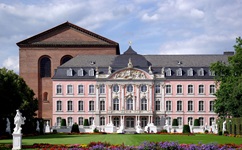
112;68;148;80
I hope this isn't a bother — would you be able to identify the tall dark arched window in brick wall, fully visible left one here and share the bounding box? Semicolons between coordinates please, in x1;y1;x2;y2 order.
40;57;51;78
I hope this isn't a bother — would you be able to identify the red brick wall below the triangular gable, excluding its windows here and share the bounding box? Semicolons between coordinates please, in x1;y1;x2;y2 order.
19;47;116;123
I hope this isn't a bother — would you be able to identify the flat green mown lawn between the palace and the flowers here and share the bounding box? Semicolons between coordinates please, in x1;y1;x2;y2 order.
0;134;242;146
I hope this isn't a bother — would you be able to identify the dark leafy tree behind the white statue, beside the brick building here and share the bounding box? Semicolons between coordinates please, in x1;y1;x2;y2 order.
0;68;38;119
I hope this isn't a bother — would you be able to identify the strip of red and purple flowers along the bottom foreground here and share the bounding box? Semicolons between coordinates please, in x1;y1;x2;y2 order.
0;141;242;150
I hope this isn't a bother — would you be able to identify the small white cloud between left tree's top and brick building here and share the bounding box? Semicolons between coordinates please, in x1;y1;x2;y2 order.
2;56;19;73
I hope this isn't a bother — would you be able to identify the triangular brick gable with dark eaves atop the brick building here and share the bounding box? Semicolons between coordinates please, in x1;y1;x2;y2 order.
17;22;120;54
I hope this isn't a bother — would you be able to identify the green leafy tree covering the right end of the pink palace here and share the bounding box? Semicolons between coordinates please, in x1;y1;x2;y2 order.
210;37;242;117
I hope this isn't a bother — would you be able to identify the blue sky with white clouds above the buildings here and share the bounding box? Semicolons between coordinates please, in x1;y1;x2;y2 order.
0;0;242;73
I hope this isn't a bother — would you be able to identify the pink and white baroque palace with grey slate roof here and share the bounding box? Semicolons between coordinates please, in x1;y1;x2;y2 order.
52;46;233;129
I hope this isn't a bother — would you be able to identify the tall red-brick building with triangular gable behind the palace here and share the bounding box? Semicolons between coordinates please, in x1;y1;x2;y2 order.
17;22;120;124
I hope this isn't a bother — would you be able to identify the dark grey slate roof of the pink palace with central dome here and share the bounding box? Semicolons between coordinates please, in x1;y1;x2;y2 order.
53;47;229;79
